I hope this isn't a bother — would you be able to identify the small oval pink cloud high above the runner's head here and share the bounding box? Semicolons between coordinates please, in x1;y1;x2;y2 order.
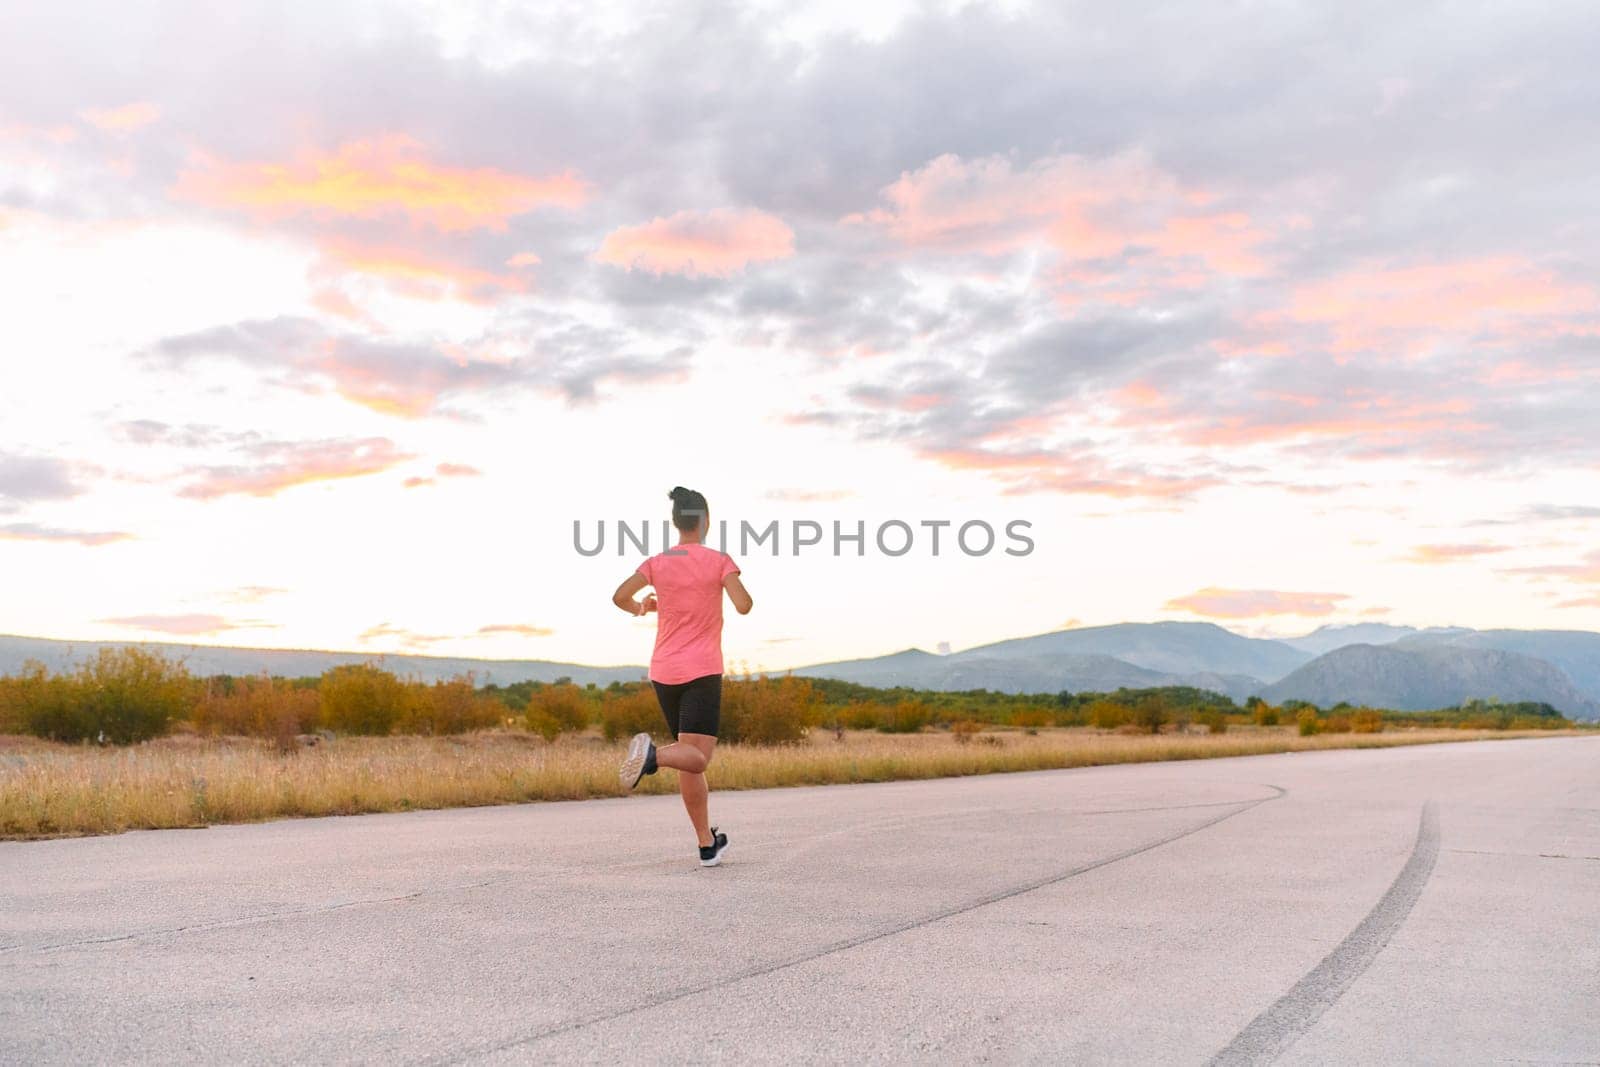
594;208;795;278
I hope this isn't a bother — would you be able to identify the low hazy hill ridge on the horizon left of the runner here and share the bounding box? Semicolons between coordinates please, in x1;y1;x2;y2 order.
0;635;645;685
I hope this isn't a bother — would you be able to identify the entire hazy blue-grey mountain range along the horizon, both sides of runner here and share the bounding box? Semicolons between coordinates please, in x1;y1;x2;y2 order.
0;622;1600;718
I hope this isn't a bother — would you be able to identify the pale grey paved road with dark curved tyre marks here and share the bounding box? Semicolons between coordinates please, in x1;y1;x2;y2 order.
0;737;1600;1064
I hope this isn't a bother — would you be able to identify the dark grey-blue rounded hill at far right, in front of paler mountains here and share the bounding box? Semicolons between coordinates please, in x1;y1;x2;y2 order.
1261;645;1600;718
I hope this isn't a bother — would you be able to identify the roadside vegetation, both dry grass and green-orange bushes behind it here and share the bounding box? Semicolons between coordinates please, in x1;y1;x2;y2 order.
0;648;1574;838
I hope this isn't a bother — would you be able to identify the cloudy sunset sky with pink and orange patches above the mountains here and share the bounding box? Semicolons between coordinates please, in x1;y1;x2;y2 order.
0;0;1600;669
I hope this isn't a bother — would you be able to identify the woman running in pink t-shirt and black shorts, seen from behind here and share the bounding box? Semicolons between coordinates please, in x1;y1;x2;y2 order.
611;485;750;867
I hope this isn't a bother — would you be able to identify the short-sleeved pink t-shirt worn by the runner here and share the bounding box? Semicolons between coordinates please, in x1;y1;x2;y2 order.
638;544;739;685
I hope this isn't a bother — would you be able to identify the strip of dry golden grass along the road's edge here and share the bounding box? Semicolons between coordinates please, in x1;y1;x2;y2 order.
0;726;1574;838
